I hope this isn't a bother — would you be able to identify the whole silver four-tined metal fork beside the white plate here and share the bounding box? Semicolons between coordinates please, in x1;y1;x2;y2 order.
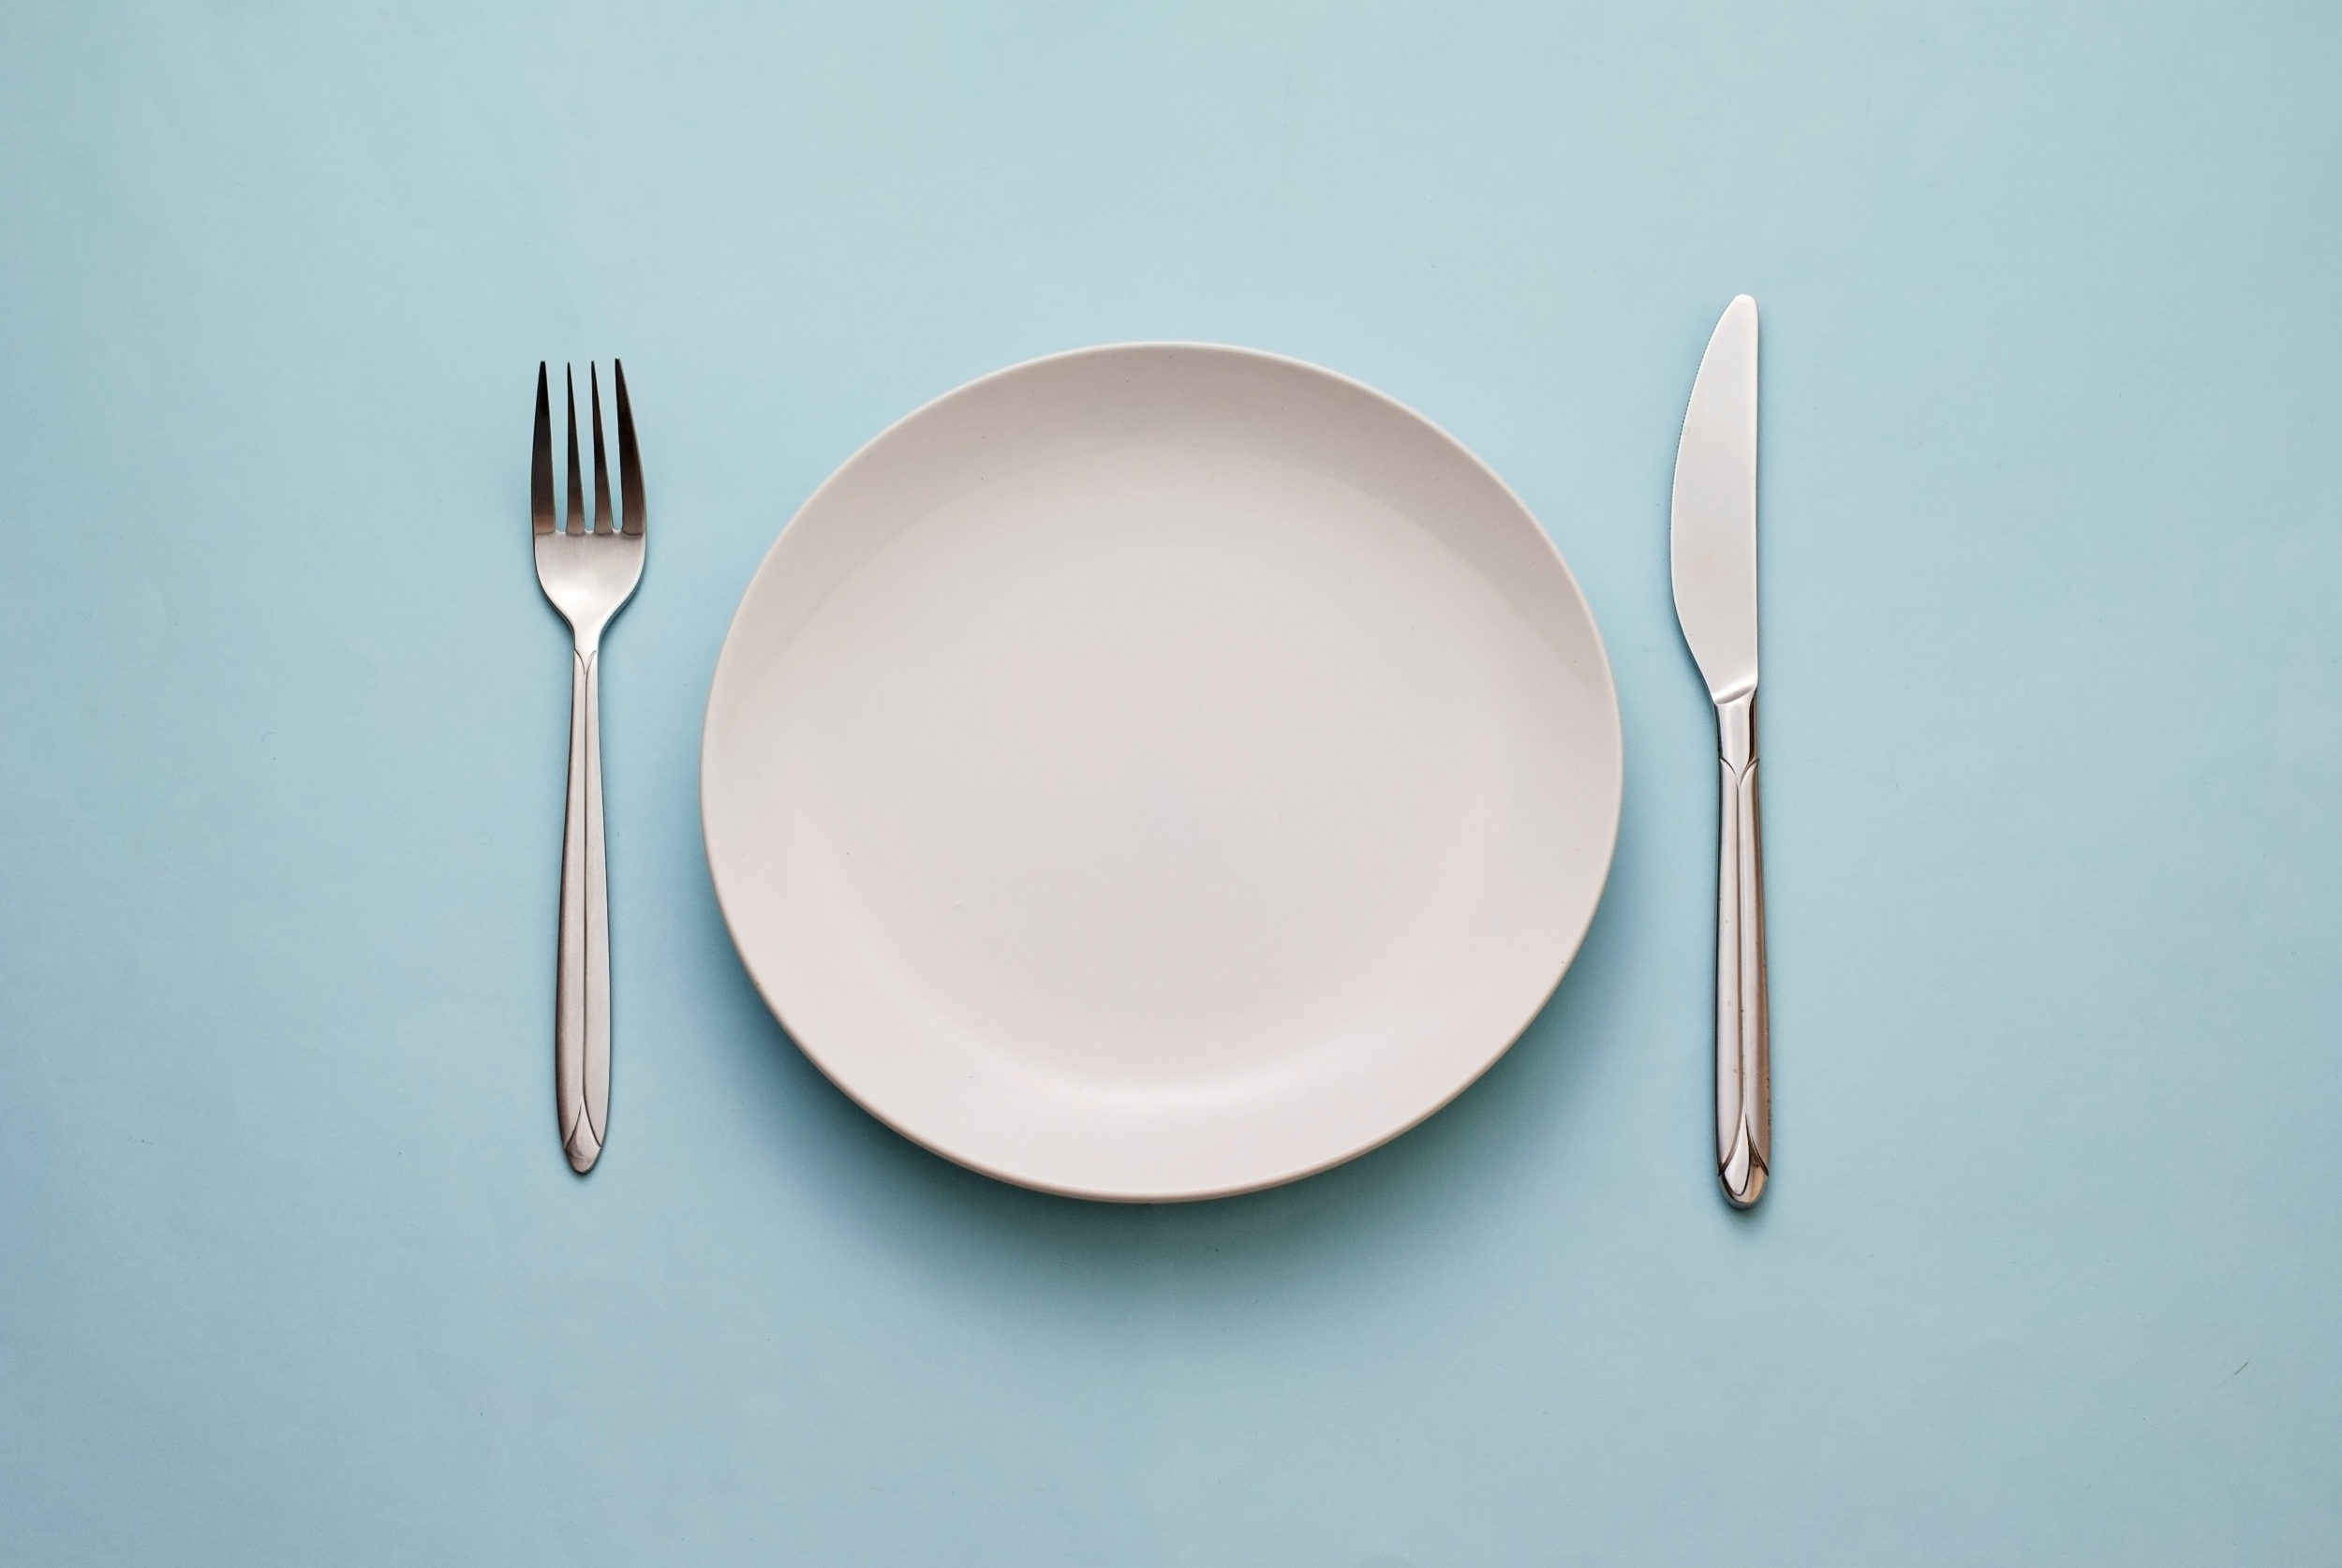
529;361;645;1175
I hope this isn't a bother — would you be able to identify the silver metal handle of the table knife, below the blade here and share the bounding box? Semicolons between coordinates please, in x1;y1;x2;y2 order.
1717;690;1773;1207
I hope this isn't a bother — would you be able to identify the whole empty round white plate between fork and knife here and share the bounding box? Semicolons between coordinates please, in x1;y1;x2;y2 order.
701;344;1621;1201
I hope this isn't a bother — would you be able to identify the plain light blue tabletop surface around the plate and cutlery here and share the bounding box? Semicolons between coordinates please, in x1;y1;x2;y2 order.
0;0;2342;1568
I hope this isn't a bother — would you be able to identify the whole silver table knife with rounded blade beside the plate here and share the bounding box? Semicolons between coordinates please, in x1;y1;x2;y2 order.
1668;295;1773;1207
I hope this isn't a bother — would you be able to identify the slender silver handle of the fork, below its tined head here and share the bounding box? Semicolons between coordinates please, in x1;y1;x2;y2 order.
553;648;609;1175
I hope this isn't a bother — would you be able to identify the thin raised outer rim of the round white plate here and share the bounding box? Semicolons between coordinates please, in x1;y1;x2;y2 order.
698;337;1625;1203
